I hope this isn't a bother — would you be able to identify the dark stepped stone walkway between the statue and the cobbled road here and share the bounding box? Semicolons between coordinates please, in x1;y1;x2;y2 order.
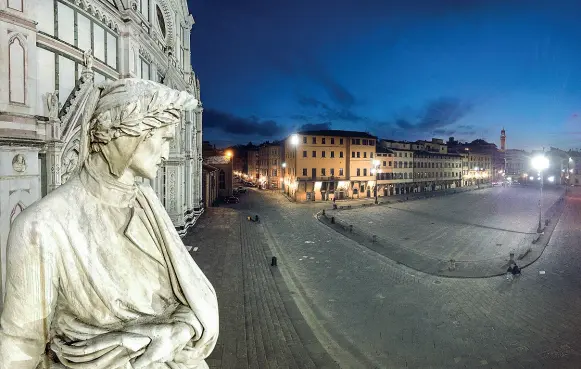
184;208;338;369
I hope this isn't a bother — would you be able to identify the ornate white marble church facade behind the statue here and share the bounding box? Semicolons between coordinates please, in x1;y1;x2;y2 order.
0;0;203;300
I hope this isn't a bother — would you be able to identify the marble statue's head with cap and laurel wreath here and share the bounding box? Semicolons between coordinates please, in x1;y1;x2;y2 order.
87;78;198;179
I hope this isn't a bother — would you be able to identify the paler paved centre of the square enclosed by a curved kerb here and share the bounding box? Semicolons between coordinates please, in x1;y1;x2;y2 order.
327;187;564;262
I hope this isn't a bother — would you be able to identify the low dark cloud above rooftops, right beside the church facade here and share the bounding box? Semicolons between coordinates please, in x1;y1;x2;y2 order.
203;108;285;137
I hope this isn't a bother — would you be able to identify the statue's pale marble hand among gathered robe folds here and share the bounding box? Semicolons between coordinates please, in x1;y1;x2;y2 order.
132;323;194;369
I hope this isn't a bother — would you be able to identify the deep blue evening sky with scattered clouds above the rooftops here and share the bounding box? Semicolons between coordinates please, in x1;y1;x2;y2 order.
188;0;581;150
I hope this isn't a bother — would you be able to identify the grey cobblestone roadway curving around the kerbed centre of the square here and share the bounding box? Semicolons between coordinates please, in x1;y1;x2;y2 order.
242;187;581;369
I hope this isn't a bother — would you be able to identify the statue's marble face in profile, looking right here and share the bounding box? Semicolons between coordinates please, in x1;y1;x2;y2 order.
127;124;175;179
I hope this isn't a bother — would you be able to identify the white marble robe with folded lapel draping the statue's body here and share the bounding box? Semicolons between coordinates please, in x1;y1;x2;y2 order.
0;166;218;369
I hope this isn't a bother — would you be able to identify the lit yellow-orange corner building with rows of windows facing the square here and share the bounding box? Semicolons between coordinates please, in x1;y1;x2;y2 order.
283;130;377;201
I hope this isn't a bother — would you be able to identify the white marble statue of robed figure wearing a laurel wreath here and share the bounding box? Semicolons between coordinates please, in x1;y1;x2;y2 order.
0;79;218;369
